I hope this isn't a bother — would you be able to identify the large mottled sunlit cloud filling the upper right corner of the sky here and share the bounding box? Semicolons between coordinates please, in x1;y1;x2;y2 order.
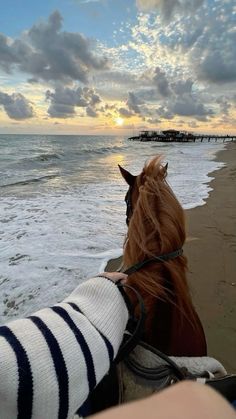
129;0;236;86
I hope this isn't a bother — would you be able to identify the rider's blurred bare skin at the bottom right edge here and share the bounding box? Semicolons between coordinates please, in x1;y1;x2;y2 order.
93;381;236;419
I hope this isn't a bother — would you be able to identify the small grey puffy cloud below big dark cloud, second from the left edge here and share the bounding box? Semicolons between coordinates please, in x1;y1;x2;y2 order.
46;86;101;118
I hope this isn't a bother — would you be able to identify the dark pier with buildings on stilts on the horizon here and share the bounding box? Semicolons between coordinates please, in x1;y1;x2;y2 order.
128;130;236;143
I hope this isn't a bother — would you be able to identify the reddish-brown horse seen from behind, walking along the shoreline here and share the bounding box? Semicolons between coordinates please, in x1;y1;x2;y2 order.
119;156;207;356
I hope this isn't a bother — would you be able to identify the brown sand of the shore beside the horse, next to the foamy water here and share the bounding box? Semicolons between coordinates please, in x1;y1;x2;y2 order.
107;143;236;373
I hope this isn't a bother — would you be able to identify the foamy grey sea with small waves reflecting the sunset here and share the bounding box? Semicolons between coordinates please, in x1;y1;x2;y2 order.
0;135;227;323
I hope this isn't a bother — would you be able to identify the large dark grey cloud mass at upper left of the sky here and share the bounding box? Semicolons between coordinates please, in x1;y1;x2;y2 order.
0;11;108;83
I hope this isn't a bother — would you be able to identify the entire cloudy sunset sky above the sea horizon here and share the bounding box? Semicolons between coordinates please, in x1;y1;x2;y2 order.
0;0;236;135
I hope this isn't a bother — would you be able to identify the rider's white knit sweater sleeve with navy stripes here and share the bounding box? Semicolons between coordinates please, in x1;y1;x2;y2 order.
0;278;128;419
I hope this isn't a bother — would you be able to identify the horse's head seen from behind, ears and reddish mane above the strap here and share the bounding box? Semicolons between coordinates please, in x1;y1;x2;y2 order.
119;156;185;263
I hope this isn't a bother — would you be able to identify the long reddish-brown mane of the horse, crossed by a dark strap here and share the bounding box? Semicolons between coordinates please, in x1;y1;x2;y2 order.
123;156;195;330
